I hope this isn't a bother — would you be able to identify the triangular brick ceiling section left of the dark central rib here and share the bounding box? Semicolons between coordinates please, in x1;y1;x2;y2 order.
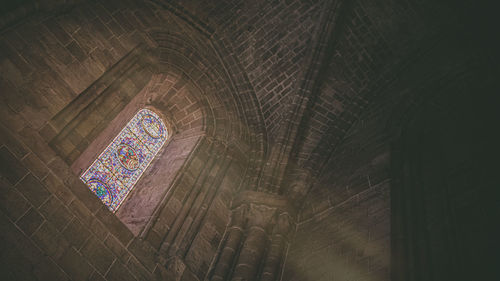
162;0;324;139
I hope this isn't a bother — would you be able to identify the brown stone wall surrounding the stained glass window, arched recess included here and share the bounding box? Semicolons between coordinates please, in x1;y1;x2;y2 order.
0;1;262;280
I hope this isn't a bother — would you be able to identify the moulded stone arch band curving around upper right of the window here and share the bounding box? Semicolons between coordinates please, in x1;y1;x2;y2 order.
149;26;268;189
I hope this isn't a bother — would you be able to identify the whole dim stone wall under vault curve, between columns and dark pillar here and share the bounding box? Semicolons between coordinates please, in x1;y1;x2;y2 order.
283;82;391;280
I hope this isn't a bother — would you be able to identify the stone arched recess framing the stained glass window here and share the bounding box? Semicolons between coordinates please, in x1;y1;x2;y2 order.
15;4;274;254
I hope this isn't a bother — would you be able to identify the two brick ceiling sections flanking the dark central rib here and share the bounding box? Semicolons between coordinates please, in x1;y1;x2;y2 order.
0;0;472;199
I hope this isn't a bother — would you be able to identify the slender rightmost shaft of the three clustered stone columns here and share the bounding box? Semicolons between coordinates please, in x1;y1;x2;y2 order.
261;213;291;281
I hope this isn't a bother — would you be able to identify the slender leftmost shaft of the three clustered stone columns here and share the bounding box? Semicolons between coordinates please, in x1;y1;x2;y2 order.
211;205;248;281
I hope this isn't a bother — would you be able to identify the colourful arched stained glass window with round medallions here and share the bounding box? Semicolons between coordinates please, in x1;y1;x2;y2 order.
80;109;168;212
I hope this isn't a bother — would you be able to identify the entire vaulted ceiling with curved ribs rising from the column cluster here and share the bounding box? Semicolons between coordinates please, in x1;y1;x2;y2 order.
1;0;484;206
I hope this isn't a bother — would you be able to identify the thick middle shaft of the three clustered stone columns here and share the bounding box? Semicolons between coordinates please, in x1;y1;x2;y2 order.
231;204;276;281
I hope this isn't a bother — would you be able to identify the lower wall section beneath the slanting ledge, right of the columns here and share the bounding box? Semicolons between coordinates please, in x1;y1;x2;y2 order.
283;183;390;280
